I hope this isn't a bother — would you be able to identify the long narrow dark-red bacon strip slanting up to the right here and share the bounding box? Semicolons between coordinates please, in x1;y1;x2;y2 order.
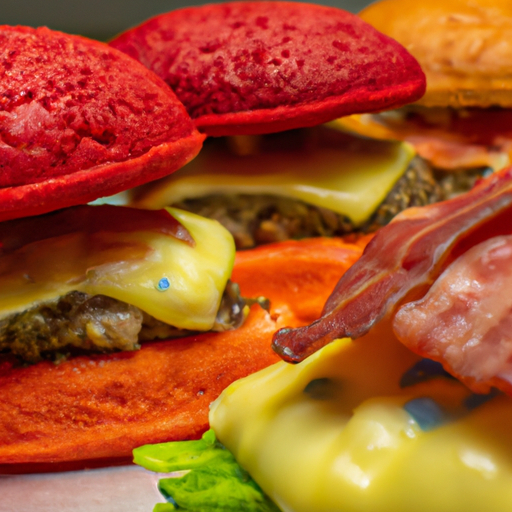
273;168;512;362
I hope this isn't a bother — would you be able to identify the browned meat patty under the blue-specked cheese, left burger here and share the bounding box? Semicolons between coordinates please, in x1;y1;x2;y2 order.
0;282;246;363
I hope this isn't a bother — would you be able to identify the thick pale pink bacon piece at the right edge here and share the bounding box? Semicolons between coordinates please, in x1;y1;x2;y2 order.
393;235;512;392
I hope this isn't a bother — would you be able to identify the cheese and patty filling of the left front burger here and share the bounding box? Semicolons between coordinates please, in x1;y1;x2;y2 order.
0;206;244;362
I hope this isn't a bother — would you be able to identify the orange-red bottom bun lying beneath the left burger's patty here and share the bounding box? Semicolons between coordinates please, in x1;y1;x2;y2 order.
0;239;362;472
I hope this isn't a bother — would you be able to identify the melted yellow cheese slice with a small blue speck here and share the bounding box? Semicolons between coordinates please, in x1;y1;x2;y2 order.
0;209;235;330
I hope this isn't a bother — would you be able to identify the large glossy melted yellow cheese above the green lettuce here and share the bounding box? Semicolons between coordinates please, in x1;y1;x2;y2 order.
210;326;512;512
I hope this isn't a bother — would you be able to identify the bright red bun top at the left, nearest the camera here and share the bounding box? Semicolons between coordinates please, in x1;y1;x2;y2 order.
0;26;204;220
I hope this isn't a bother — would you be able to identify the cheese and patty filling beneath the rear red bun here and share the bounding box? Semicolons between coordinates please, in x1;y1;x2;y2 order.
135;127;479;249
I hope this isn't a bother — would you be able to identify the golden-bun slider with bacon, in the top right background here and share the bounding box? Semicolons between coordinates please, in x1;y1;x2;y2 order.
339;0;512;176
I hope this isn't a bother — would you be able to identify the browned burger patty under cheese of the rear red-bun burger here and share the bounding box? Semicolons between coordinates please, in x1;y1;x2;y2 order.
173;157;486;249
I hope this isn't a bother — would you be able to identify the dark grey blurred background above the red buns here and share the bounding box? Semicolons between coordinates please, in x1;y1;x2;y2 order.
0;0;372;41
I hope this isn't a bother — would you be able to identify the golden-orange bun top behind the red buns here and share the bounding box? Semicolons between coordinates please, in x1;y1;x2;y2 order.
360;0;512;107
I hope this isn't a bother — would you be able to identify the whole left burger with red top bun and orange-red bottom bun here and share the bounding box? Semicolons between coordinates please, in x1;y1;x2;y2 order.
0;26;266;471
